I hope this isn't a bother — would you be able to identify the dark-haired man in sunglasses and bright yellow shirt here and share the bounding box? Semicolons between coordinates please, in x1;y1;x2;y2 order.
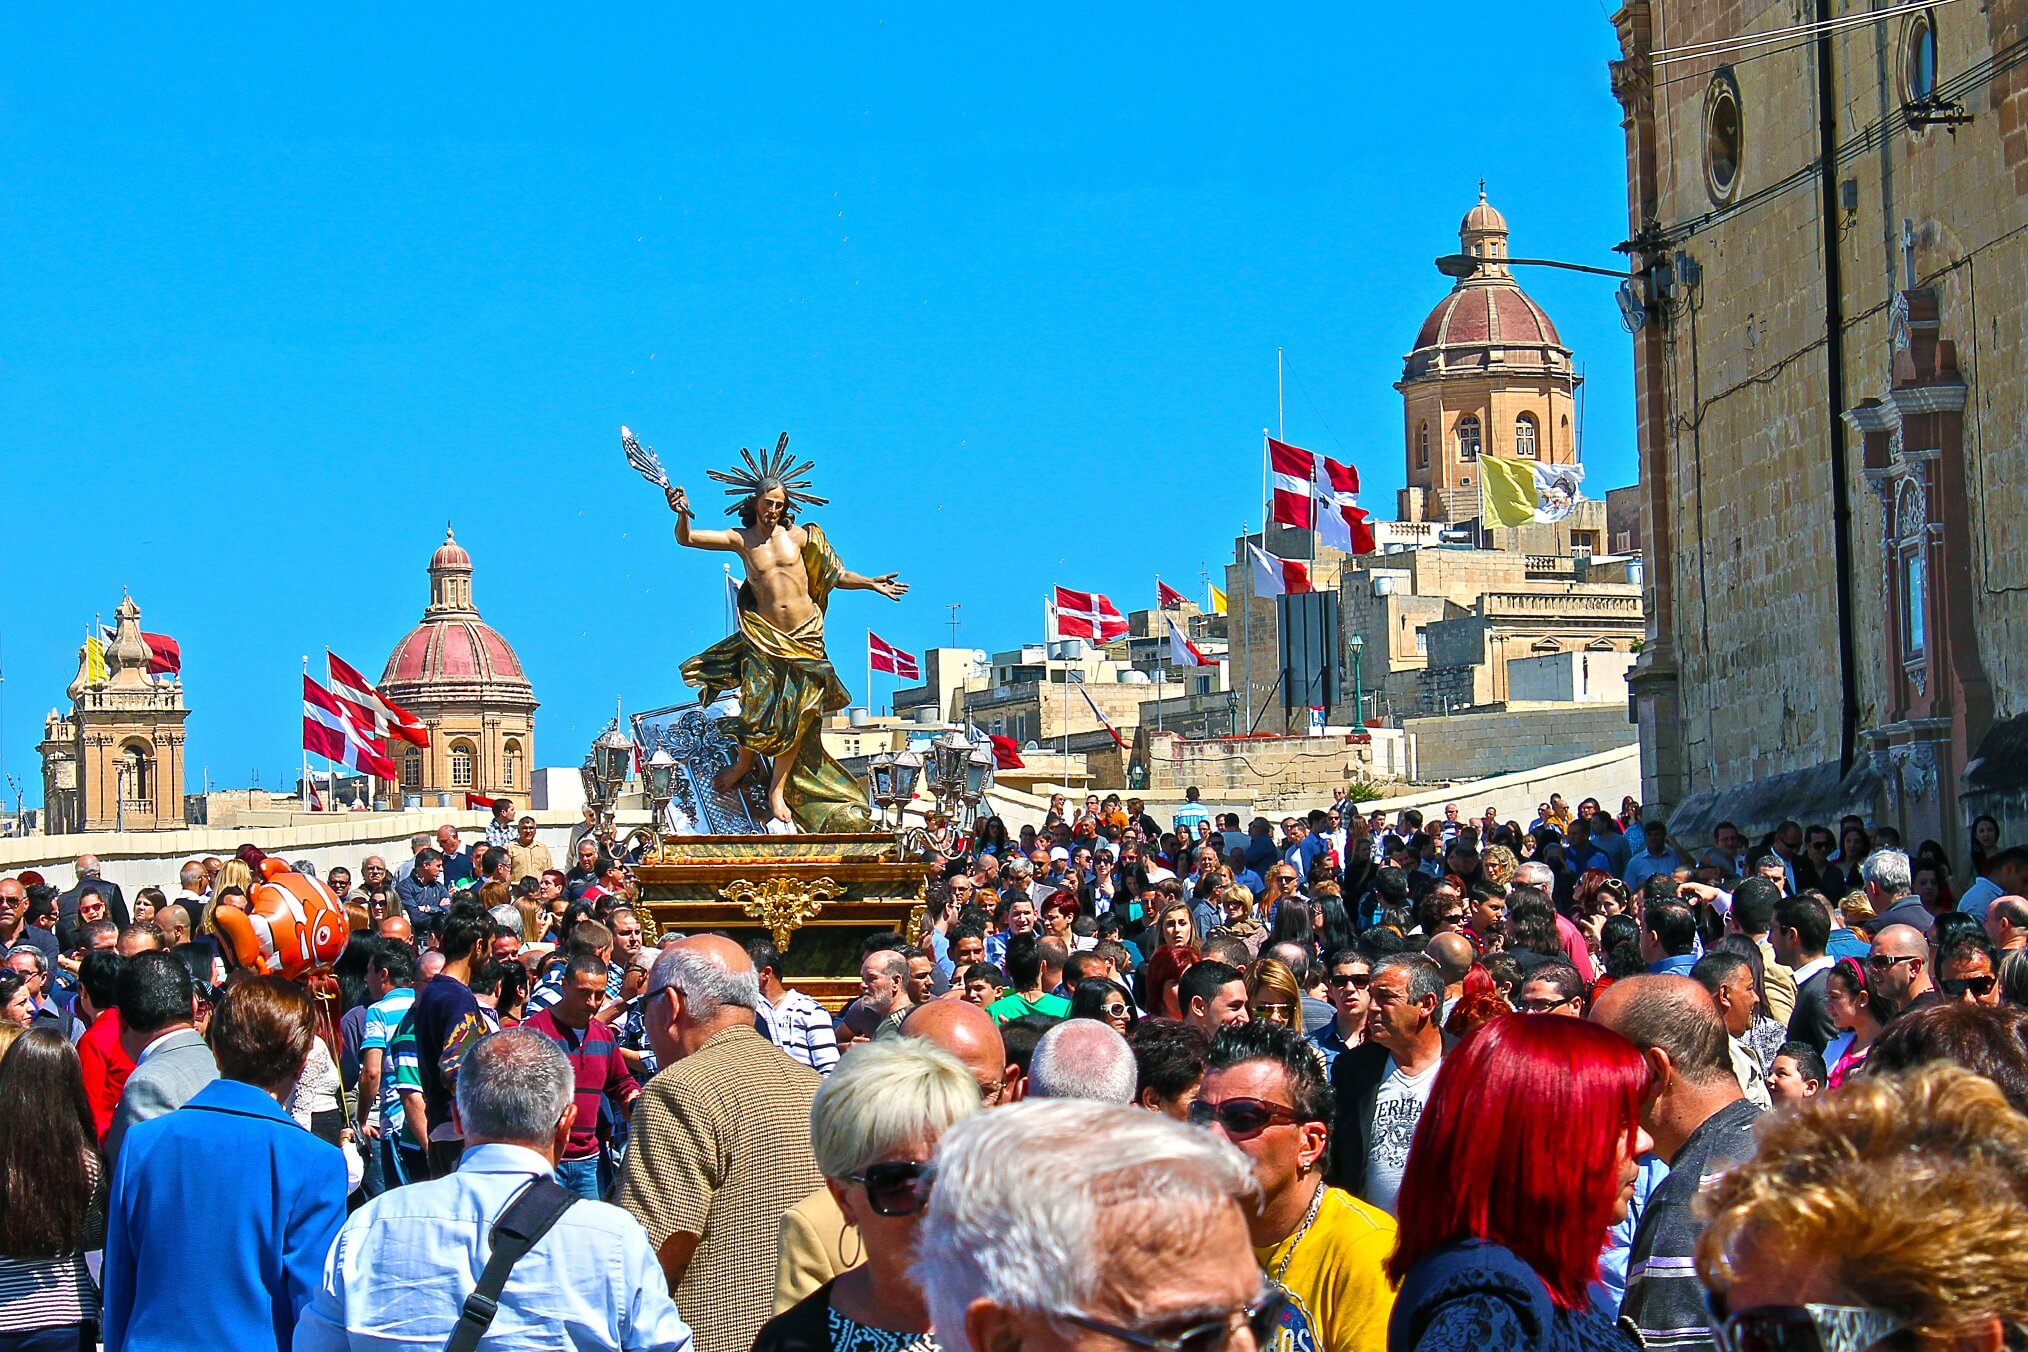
1190;1024;1395;1352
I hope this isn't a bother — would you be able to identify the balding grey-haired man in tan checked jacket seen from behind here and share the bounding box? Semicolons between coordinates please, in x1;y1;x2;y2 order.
614;934;823;1352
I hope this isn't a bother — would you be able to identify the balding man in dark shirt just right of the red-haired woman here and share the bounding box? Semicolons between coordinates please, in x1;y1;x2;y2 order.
1592;977;1768;1348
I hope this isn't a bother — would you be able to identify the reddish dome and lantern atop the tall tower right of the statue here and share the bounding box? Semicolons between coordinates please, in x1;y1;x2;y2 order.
1401;184;1572;381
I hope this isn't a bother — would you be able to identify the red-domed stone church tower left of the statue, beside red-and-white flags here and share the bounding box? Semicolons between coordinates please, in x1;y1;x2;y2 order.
379;529;537;803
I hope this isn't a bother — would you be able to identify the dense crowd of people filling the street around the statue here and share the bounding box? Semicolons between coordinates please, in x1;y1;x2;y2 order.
0;791;2028;1352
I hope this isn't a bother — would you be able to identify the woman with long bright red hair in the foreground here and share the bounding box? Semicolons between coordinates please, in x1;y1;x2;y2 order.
1387;1013;1653;1352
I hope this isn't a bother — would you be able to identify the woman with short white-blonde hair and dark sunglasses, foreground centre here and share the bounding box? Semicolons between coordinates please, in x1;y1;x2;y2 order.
752;1038;980;1352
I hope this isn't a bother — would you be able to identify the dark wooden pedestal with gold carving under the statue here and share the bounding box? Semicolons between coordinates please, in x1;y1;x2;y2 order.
635;833;931;1009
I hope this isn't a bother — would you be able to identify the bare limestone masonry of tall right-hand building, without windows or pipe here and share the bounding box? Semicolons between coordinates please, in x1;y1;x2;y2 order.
1612;0;2028;847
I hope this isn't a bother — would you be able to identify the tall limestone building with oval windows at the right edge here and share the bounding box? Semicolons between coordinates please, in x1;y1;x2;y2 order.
1612;0;2028;847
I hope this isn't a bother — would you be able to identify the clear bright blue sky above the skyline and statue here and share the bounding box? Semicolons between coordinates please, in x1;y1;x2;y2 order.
0;0;1635;803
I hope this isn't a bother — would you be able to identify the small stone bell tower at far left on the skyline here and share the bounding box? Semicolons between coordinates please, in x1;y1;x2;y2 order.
41;596;191;835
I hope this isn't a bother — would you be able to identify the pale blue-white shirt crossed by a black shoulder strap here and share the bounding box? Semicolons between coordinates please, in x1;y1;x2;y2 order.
294;1145;690;1352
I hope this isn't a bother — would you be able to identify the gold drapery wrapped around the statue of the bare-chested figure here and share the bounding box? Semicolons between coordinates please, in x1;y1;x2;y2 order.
683;525;872;831
